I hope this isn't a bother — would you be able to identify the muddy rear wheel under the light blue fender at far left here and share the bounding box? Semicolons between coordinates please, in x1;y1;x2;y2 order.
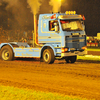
0;45;14;61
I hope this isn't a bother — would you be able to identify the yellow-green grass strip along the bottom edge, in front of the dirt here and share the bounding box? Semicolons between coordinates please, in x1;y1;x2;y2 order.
0;85;87;100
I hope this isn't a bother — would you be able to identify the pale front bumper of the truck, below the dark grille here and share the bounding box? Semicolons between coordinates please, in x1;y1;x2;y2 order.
61;50;87;58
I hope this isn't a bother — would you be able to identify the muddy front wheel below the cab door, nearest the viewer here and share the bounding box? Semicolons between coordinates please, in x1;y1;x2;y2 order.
43;49;55;64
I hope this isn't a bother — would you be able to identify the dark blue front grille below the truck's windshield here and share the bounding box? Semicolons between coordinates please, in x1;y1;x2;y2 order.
65;35;86;49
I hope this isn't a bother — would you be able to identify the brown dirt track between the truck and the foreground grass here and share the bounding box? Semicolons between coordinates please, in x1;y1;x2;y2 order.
0;59;100;100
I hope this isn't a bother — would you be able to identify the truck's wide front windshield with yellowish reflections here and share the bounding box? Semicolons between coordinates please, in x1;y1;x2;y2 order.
60;20;84;31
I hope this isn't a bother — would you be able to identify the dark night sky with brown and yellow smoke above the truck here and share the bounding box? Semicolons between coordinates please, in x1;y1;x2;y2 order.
0;0;100;36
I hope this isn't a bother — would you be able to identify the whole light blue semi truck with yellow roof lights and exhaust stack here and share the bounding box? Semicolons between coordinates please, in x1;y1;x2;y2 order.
0;11;87;64
